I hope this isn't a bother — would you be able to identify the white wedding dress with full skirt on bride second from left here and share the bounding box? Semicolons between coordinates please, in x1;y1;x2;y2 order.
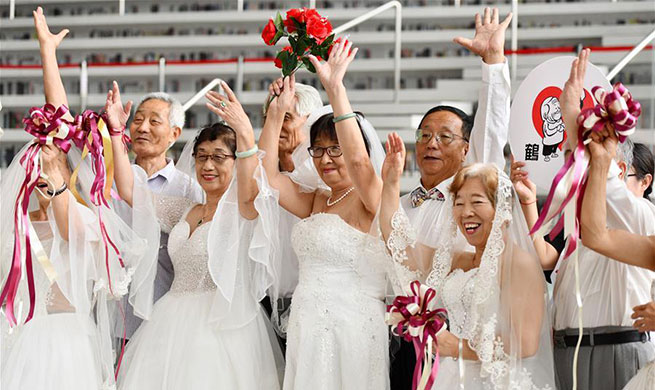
118;196;279;390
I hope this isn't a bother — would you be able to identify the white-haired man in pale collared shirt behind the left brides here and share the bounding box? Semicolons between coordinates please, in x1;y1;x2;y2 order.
113;87;204;339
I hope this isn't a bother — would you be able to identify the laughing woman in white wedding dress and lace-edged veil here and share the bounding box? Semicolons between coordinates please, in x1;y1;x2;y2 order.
380;133;554;390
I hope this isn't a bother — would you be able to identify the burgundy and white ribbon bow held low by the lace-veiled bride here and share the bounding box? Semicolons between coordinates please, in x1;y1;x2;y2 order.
386;280;446;390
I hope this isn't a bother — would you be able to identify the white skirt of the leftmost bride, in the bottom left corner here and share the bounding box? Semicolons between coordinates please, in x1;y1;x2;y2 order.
0;313;102;390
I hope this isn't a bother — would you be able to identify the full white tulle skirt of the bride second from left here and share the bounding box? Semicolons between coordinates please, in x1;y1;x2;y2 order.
118;292;283;390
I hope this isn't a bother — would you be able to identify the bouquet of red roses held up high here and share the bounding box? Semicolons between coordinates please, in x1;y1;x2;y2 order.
262;8;334;76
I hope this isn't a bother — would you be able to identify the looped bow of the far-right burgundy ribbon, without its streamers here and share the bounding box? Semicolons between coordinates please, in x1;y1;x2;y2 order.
578;83;641;142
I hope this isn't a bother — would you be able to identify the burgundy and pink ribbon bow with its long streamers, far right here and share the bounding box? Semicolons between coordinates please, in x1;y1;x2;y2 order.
530;83;641;259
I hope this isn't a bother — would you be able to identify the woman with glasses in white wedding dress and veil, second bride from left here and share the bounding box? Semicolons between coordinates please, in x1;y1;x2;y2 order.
106;78;282;390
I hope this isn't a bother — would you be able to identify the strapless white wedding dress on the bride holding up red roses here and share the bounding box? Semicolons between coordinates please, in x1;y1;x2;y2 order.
284;213;389;390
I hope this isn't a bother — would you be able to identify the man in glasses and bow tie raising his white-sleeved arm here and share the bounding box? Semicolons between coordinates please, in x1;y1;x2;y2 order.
391;8;511;388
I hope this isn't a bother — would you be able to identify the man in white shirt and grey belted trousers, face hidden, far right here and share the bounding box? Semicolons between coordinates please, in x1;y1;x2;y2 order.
553;50;655;390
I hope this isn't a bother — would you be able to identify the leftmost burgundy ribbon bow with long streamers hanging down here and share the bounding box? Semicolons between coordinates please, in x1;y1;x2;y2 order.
0;104;81;326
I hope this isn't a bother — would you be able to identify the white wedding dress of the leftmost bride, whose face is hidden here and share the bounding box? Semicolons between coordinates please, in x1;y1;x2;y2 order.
0;222;103;390
